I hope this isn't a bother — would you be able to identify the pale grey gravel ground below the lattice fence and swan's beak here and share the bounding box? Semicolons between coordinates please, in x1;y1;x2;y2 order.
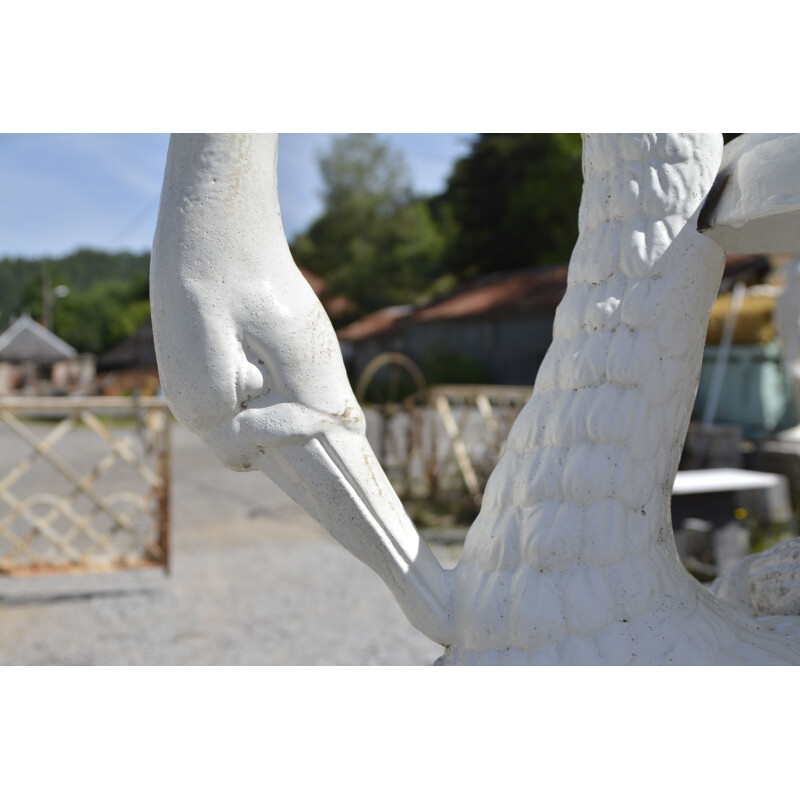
0;426;459;665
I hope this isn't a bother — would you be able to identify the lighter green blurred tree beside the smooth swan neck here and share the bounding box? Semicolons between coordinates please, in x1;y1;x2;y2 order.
292;133;444;313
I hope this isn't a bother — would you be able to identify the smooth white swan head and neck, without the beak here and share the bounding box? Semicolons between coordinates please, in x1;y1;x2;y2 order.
150;134;364;469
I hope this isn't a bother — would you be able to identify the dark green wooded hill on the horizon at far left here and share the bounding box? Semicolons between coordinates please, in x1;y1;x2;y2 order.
0;250;150;330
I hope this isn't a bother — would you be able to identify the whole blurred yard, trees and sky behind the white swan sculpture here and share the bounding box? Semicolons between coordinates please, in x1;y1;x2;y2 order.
0;133;800;664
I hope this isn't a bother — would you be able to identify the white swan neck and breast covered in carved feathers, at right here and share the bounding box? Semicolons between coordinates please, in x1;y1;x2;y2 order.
444;134;800;664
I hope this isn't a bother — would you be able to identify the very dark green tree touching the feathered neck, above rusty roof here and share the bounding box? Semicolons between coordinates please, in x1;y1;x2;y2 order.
434;133;583;278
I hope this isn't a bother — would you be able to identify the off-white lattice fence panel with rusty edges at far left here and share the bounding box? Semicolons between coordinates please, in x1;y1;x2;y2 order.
0;397;170;575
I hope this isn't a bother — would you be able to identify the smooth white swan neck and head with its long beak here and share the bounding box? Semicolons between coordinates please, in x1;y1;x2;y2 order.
151;134;451;643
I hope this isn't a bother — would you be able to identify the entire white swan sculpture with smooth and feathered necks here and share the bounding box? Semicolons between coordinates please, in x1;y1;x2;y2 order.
150;134;800;664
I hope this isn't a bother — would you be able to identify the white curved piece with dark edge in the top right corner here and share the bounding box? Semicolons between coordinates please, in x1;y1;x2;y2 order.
697;133;800;253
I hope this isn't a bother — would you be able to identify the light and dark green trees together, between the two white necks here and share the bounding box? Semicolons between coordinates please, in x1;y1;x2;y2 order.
292;133;582;313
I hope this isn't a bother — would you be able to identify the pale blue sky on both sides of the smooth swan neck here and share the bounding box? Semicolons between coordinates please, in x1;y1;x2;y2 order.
0;133;474;258
